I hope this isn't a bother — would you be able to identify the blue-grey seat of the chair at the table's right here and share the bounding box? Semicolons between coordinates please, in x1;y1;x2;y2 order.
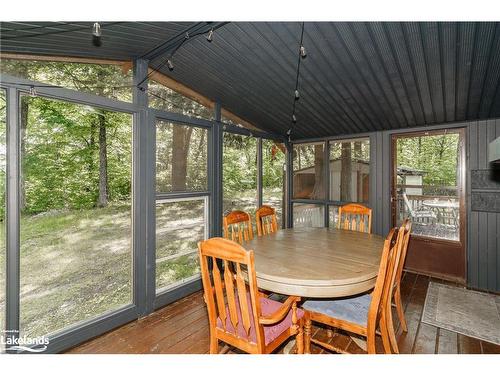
302;294;372;327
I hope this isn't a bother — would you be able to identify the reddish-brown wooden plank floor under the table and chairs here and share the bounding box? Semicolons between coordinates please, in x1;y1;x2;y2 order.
68;273;500;354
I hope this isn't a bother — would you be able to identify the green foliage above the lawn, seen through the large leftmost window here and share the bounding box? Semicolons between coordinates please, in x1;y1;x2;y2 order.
22;96;132;213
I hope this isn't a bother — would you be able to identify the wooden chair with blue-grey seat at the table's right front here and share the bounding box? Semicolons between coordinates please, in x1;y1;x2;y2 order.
302;228;402;354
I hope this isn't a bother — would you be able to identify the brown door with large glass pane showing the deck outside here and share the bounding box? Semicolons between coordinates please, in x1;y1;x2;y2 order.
391;129;466;282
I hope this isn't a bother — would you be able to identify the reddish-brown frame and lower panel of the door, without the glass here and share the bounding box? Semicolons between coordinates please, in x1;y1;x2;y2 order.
390;127;467;284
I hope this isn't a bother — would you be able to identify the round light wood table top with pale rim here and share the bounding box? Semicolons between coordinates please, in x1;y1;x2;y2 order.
245;228;384;298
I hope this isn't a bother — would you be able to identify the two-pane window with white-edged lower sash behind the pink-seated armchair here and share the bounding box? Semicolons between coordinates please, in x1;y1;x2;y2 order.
156;120;209;293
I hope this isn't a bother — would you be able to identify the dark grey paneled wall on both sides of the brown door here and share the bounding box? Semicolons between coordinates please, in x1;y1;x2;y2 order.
370;119;500;292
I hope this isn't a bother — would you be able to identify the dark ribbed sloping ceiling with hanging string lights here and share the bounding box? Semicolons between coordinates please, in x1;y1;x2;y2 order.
0;22;500;138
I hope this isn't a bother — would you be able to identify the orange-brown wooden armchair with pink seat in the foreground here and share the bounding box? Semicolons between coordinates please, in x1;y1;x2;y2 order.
198;238;304;354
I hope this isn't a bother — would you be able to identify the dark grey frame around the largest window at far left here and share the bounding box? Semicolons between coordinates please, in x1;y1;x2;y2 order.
0;75;142;353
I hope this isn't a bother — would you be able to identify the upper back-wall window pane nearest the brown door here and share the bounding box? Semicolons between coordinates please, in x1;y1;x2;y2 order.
329;138;370;204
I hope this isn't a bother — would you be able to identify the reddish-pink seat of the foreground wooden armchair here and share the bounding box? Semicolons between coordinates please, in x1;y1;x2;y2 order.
217;292;304;345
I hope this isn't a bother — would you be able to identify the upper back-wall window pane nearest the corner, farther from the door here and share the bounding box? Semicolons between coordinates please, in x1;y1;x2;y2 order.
293;142;325;200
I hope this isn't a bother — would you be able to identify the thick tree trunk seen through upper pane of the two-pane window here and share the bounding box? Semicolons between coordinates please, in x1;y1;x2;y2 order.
172;125;193;191
